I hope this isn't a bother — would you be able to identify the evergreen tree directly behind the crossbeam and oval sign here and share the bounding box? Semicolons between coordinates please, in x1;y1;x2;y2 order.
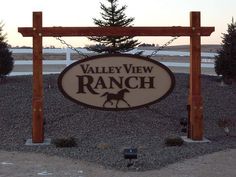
88;0;139;53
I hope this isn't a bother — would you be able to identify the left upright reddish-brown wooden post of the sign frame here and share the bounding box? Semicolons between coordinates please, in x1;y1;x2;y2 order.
32;12;44;143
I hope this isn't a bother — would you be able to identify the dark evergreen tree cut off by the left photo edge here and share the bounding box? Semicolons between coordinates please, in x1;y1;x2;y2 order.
0;23;14;79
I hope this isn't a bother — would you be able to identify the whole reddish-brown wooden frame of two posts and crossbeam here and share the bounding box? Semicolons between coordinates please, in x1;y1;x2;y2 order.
18;12;214;143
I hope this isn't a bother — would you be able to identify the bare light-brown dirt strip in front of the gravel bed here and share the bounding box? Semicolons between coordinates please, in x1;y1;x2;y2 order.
0;149;236;177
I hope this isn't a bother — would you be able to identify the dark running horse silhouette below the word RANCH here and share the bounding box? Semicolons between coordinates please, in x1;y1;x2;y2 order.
101;89;130;108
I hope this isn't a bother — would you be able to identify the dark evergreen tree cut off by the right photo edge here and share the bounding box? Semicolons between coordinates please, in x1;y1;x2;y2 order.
215;19;236;80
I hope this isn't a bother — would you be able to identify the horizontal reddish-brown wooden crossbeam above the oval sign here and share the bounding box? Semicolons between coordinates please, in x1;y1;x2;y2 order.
18;26;214;37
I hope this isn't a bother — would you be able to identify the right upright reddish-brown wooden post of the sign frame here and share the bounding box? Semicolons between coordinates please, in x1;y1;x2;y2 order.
188;12;203;140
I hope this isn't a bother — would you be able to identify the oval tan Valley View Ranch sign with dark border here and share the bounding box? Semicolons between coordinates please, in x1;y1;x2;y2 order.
58;54;175;111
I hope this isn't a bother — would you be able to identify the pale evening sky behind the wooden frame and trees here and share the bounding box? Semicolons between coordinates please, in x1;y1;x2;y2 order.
0;0;236;47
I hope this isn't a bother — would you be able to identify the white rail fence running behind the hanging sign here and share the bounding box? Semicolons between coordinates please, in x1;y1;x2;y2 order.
10;48;216;75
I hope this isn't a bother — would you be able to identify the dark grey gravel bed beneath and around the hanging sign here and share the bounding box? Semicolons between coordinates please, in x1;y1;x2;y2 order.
0;74;236;171
